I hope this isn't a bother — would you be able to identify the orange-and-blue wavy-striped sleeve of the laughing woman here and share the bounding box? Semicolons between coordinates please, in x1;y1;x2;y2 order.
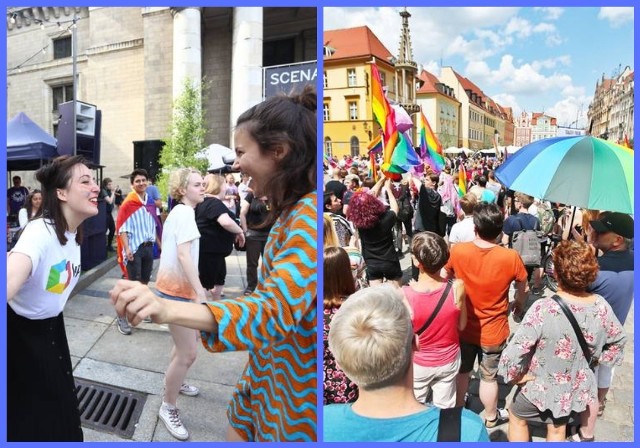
201;194;317;352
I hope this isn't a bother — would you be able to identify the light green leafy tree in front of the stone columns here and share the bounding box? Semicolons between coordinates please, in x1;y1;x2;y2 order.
157;78;207;199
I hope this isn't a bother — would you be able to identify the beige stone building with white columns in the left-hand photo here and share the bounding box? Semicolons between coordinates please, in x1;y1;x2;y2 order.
7;7;317;189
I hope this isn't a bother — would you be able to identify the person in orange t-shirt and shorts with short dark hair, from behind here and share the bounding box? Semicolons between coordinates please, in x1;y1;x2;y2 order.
444;202;529;428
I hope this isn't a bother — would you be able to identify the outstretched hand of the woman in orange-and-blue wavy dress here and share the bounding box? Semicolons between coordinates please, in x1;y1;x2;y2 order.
109;280;167;326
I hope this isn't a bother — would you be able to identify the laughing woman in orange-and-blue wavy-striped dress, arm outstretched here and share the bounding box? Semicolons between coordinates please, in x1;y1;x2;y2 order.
111;87;317;441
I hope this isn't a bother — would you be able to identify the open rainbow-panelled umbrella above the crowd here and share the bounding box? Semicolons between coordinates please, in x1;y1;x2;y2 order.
495;136;633;214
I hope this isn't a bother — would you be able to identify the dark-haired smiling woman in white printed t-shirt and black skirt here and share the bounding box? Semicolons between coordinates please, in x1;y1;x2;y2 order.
6;156;100;442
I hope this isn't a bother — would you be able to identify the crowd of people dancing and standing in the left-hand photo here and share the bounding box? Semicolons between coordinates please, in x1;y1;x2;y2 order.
7;87;317;441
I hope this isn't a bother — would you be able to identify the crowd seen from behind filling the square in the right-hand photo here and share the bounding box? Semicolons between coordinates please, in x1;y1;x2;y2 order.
323;156;633;441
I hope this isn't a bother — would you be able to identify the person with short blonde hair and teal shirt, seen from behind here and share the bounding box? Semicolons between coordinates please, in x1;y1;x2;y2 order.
323;285;489;442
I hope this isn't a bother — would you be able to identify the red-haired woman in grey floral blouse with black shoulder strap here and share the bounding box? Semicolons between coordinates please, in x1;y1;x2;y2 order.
498;241;626;442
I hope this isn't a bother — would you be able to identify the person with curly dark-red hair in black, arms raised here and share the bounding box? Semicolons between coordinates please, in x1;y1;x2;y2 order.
347;178;402;287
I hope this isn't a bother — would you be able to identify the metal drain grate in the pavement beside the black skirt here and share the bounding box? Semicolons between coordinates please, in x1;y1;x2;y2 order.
76;378;147;439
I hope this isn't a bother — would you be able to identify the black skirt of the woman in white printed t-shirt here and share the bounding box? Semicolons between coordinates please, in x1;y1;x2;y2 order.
7;305;83;442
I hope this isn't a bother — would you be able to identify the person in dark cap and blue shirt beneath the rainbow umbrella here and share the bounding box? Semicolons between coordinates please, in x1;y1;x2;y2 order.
571;212;633;441
